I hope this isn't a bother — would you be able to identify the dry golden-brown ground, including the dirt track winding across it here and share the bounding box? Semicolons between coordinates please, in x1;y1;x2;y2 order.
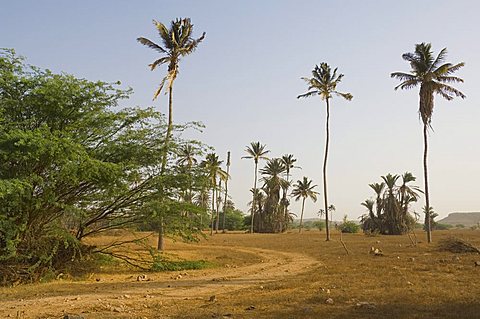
0;230;480;319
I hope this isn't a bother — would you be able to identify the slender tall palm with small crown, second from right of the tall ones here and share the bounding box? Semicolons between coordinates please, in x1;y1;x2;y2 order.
297;63;353;241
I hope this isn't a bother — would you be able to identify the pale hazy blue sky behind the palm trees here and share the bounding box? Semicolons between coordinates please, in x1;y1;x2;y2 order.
0;0;480;219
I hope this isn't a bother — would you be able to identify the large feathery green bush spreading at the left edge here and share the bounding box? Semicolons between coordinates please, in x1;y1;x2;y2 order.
0;50;210;281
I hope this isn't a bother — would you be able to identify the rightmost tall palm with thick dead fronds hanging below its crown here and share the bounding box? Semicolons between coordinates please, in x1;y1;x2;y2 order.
391;43;465;243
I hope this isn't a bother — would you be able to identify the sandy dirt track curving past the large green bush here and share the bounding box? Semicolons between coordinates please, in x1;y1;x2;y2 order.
0;246;319;319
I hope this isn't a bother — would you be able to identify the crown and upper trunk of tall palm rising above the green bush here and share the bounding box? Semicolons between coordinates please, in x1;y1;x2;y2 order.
137;18;205;173
